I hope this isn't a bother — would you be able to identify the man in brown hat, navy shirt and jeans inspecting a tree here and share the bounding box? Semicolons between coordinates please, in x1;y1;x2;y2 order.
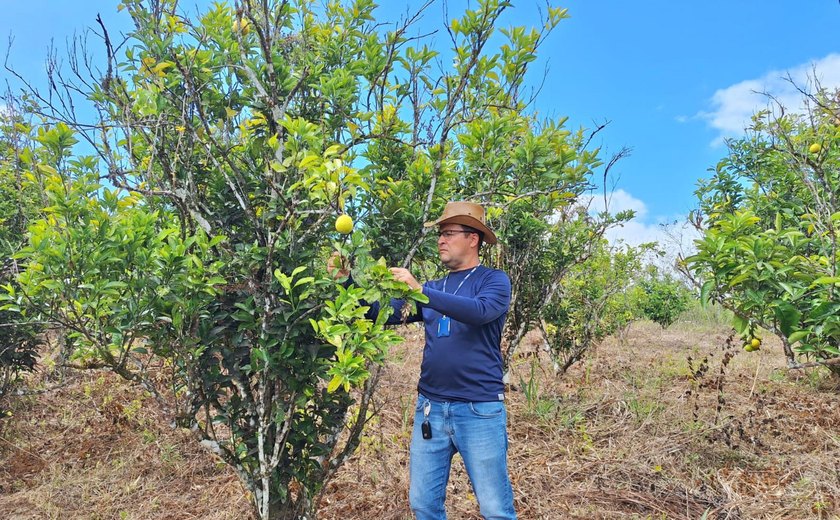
338;202;516;520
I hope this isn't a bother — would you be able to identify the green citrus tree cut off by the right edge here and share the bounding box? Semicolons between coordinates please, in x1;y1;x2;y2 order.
685;85;840;372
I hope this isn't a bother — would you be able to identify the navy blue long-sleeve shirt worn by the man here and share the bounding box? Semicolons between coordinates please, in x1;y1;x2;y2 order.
370;266;510;401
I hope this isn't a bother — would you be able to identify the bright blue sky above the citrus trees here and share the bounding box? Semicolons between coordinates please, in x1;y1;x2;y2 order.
0;0;840;252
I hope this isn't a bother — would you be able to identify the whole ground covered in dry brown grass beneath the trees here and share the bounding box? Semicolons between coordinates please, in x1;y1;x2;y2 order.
0;322;840;520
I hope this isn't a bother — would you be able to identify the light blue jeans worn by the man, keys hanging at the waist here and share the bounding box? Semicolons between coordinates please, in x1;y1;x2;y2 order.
408;394;516;520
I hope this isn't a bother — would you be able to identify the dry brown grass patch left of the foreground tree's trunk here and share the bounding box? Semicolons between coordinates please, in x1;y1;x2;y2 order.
0;373;249;520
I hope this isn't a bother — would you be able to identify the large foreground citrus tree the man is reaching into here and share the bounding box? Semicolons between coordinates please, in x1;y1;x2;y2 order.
6;2;418;518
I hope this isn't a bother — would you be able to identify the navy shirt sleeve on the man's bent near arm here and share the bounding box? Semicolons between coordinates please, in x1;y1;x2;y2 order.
423;271;510;325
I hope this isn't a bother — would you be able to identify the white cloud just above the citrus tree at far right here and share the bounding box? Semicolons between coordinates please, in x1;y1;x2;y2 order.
697;53;840;145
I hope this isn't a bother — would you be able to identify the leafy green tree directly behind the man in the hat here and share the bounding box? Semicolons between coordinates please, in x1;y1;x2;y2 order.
356;9;632;367
